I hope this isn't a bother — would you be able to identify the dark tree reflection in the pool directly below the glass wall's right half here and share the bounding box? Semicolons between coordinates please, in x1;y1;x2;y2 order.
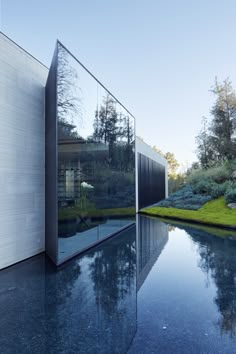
90;228;136;316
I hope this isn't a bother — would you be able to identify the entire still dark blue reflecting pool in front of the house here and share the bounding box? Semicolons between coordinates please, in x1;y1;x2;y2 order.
0;216;236;354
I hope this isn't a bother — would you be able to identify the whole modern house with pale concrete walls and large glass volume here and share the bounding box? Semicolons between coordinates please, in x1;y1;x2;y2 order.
0;33;168;269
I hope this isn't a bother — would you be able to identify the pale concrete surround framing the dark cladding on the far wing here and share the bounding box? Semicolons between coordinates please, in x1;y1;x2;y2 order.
135;137;168;211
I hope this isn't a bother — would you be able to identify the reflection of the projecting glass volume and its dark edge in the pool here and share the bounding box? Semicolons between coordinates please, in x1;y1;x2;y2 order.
45;228;136;353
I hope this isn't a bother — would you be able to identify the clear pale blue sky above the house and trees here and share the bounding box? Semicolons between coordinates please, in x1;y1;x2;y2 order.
0;0;236;165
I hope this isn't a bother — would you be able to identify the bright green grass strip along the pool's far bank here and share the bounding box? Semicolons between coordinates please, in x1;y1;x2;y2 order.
140;197;236;229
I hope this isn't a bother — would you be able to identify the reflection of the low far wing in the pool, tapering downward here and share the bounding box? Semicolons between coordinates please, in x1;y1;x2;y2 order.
137;215;168;290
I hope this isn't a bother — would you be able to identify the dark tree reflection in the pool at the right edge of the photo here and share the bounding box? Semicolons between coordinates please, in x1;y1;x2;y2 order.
184;227;236;336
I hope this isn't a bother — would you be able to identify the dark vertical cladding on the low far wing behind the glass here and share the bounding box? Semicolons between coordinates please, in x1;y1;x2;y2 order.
138;153;165;209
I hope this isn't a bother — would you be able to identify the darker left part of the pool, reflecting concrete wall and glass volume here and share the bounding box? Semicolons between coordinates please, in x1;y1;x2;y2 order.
0;226;137;354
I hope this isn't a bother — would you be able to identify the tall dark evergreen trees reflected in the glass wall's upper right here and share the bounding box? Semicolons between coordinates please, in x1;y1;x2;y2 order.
93;93;134;171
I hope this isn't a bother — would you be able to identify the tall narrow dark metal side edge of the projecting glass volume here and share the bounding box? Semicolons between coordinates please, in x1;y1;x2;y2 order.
45;46;58;264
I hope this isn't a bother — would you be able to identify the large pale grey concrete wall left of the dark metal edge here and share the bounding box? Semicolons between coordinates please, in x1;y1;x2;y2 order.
0;32;48;269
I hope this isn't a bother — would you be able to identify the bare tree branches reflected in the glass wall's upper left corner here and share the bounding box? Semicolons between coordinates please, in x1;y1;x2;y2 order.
57;44;80;138
